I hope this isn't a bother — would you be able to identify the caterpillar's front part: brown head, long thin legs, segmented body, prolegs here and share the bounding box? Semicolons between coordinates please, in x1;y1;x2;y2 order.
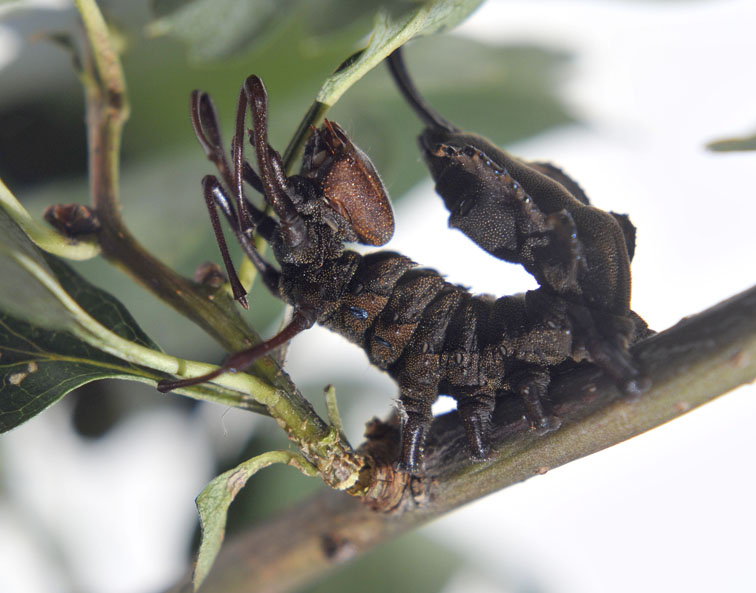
158;76;640;471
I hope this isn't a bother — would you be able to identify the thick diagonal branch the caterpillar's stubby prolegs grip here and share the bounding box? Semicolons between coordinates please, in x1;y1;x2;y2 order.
175;287;756;593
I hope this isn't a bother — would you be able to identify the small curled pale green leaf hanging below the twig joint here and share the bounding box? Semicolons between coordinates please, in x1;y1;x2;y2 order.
193;451;318;591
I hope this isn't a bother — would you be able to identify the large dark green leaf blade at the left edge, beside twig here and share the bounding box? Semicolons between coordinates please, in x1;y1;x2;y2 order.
0;204;165;432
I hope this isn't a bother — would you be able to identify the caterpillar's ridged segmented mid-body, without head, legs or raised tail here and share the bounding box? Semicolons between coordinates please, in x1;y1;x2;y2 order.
292;251;571;399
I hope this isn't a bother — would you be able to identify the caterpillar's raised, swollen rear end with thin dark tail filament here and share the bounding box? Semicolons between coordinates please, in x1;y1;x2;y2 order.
388;50;648;394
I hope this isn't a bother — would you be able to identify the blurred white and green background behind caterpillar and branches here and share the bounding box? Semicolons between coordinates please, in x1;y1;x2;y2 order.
0;0;756;593
